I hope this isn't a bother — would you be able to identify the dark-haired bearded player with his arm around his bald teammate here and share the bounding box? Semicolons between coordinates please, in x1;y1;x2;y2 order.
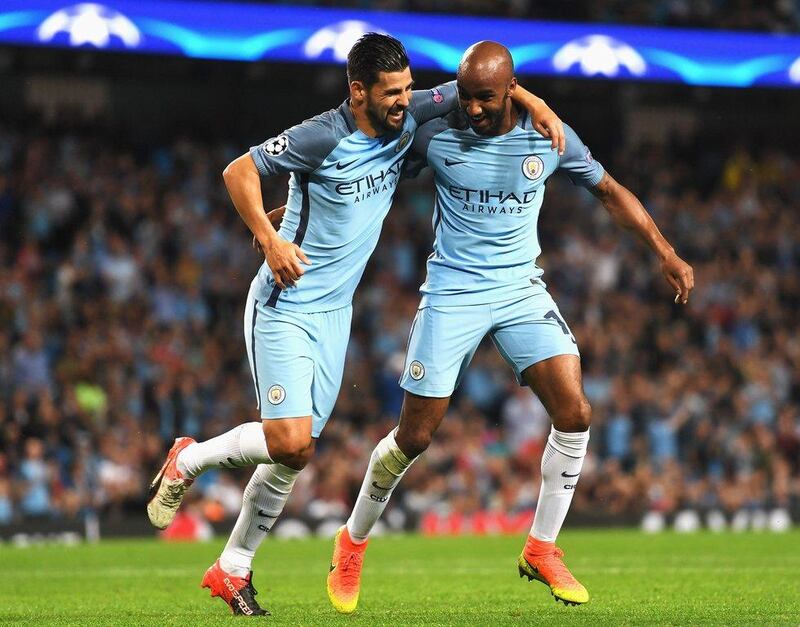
147;33;563;615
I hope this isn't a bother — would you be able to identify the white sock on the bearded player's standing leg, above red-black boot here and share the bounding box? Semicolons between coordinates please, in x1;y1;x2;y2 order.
219;464;300;577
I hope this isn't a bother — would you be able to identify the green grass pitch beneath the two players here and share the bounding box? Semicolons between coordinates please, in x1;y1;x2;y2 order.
0;530;800;627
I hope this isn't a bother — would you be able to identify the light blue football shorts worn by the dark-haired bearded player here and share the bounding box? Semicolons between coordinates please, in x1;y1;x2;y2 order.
244;281;353;438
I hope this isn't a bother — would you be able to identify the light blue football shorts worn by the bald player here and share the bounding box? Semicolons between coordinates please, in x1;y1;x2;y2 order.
400;288;579;397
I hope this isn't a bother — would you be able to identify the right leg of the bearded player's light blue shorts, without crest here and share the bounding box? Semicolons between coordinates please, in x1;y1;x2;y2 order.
311;306;353;438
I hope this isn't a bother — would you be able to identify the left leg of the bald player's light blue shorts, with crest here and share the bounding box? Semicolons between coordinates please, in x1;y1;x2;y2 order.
400;305;491;398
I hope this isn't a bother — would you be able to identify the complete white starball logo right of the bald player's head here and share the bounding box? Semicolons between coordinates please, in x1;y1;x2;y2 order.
553;35;647;78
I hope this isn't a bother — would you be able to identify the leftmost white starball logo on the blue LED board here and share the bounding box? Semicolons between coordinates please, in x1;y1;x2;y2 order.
36;2;142;48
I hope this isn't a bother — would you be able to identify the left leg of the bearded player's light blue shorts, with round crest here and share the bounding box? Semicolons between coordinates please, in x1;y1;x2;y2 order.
248;300;314;420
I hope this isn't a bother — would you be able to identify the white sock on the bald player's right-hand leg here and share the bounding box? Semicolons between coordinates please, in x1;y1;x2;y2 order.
530;427;589;542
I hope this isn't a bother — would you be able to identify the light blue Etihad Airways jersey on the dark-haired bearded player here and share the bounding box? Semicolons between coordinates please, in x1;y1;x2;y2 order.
250;81;458;312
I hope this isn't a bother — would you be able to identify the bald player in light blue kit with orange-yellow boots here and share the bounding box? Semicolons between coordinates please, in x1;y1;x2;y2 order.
327;42;694;613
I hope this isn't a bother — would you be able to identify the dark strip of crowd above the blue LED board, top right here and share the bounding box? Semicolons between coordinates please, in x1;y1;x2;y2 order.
264;0;800;32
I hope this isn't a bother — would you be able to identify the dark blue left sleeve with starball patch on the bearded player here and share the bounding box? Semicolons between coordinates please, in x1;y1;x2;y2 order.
250;114;339;176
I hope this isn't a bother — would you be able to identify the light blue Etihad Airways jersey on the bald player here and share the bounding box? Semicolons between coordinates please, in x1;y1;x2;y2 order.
404;111;604;307
